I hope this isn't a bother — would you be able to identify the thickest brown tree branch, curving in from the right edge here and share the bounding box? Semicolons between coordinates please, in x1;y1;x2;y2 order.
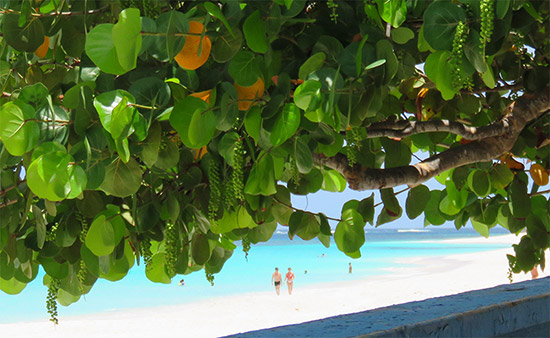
314;88;550;191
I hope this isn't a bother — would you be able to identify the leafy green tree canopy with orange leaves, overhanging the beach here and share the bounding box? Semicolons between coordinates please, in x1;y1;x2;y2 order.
0;0;550;320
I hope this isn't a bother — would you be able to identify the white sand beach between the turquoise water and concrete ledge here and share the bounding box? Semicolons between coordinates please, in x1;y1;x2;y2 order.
0;235;549;338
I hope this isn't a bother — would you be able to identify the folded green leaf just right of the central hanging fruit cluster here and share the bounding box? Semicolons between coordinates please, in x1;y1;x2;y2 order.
244;153;277;196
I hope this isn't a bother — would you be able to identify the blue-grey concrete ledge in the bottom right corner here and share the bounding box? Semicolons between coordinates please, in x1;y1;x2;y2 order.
228;277;550;338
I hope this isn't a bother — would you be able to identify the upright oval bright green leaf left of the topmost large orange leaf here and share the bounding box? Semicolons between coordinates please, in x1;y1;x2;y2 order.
111;8;141;71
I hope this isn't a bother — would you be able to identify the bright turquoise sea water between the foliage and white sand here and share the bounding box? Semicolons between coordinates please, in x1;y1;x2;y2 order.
0;228;508;323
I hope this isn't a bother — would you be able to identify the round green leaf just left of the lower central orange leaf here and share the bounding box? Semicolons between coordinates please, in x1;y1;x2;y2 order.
170;96;217;149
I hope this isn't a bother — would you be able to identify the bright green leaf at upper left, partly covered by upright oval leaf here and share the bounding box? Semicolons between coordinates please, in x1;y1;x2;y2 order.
84;23;130;75
